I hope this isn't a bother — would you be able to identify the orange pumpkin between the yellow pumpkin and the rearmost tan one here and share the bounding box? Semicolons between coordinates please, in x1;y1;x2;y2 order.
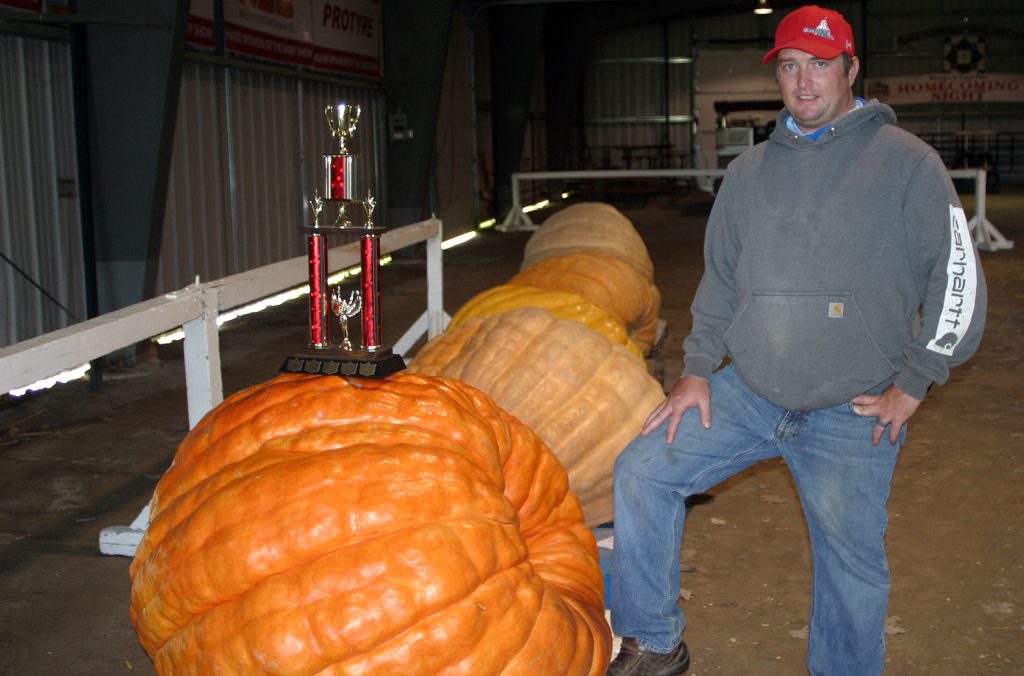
508;251;662;354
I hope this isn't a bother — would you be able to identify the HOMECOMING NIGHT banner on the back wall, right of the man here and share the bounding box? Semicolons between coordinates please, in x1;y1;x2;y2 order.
864;73;1024;105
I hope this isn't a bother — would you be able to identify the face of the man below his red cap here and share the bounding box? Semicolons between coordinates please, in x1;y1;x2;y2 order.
775;48;860;132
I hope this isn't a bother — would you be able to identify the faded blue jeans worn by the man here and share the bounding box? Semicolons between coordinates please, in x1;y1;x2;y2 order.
610;367;903;676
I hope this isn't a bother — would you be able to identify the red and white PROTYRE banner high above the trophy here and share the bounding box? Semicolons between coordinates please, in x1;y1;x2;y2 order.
221;0;381;78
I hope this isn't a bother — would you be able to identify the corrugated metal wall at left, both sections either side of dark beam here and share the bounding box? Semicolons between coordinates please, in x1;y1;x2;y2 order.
0;36;384;346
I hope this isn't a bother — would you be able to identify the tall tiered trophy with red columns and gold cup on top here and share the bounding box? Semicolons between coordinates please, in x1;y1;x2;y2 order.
281;98;406;378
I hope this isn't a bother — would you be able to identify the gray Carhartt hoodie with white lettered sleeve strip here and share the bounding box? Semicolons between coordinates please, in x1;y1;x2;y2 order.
683;100;987;411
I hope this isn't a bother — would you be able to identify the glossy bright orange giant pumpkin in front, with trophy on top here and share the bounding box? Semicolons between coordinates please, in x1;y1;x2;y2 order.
131;373;610;676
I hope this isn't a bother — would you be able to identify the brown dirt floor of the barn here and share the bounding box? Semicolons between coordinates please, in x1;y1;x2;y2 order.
0;188;1024;676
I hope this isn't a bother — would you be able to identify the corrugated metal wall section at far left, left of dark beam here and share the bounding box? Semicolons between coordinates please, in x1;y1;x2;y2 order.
0;36;85;345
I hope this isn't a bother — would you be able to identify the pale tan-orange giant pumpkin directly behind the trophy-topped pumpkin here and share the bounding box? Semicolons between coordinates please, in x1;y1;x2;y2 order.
409;307;665;525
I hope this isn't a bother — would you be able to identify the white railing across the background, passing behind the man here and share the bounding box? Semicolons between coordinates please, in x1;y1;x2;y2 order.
497;169;1014;251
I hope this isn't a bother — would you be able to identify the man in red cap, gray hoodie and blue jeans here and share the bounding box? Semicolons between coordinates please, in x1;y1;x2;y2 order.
608;5;986;676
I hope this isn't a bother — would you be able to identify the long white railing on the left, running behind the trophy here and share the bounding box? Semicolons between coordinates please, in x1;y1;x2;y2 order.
0;218;449;556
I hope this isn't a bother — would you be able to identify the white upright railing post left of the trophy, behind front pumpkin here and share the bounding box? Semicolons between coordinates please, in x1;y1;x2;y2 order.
183;286;224;429
